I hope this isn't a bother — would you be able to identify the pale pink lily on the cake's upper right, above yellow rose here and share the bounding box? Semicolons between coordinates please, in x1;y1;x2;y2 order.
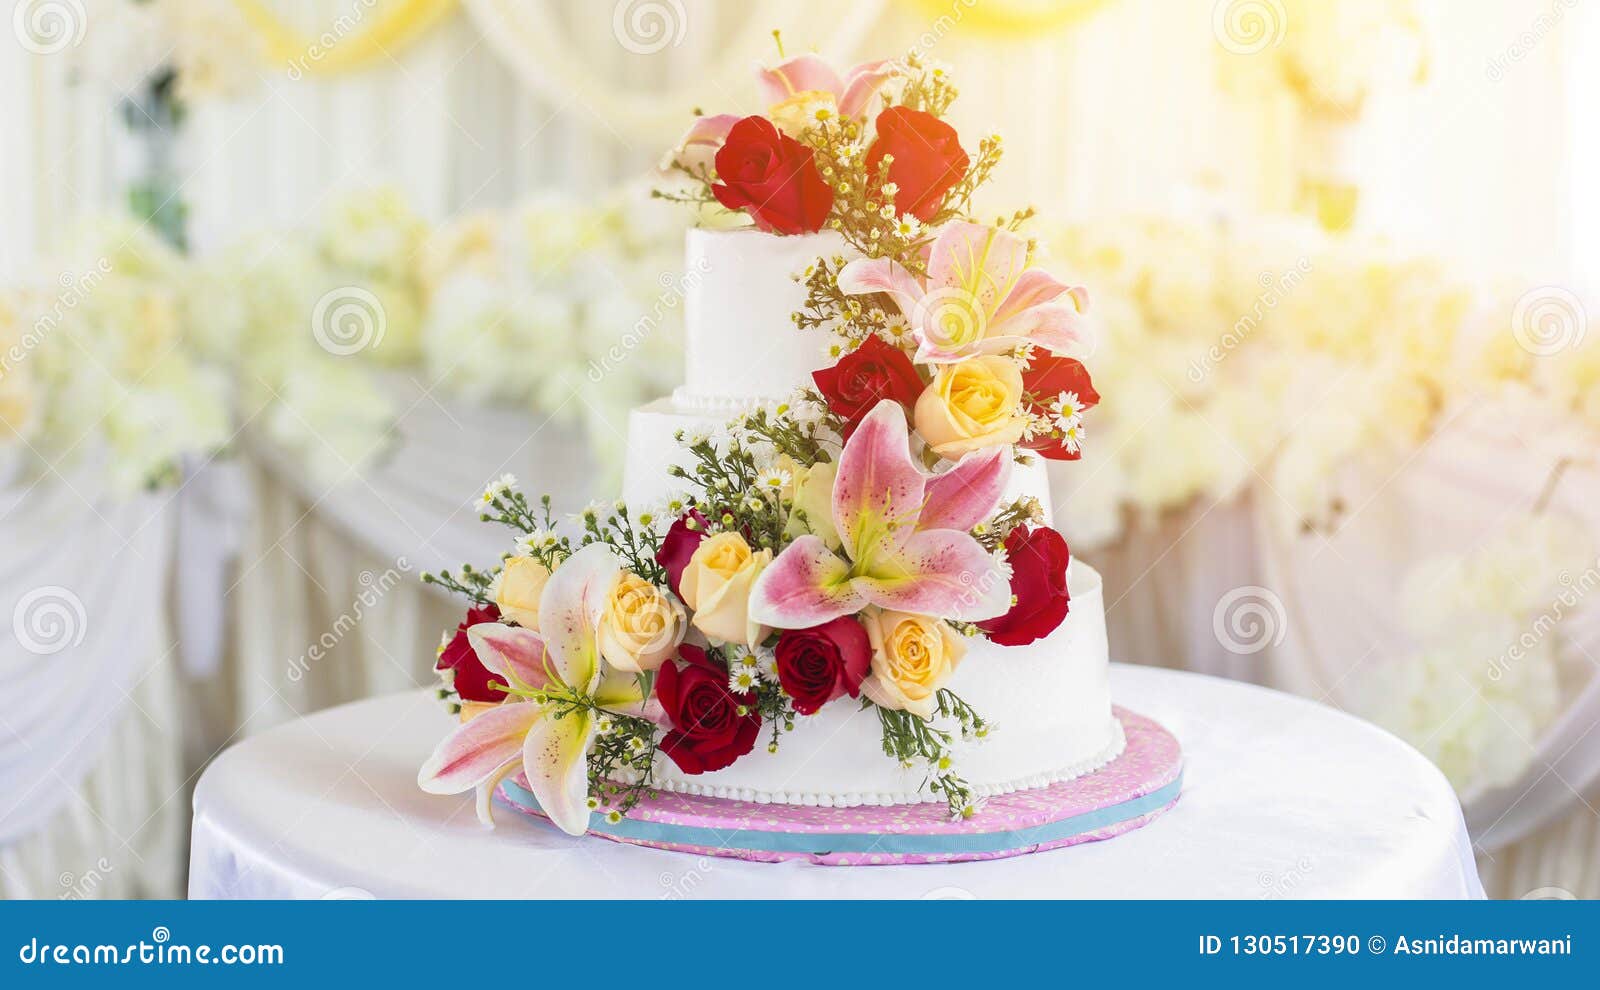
838;222;1088;365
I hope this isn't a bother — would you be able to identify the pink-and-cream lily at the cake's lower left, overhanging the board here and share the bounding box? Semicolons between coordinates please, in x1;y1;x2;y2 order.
416;544;650;835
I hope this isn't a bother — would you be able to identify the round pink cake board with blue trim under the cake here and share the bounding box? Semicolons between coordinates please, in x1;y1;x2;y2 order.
499;709;1182;867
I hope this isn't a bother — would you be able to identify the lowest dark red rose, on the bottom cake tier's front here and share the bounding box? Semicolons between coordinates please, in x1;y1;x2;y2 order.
656;645;762;774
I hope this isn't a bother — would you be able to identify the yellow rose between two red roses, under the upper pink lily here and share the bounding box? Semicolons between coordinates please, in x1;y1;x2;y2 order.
914;355;1027;461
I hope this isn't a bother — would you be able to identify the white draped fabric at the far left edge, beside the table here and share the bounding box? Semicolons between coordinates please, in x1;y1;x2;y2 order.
0;459;187;897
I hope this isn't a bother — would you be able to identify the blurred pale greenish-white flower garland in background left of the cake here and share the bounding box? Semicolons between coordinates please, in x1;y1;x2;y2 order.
187;187;693;480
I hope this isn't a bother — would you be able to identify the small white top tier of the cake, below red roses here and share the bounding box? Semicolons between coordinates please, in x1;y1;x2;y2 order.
678;229;846;406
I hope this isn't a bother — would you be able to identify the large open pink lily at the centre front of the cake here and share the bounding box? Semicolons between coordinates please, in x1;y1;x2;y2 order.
750;400;1011;629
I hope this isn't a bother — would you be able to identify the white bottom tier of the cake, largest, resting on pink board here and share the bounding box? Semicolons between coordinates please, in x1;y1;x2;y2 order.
643;561;1123;808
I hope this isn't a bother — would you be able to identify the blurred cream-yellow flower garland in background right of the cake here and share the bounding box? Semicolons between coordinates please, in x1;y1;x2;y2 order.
1046;216;1600;545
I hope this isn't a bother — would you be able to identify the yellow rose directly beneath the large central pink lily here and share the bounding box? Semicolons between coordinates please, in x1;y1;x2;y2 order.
861;608;966;718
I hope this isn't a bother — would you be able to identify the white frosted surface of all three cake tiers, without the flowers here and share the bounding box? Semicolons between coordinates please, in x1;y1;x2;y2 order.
624;229;1123;806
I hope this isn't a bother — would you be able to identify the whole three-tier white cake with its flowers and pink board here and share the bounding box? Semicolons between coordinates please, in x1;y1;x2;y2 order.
418;56;1179;864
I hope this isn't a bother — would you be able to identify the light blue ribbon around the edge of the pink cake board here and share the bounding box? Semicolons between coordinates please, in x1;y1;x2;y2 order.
501;771;1184;856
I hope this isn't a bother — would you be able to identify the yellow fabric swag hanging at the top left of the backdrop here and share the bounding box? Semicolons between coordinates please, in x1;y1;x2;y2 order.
234;0;458;75
